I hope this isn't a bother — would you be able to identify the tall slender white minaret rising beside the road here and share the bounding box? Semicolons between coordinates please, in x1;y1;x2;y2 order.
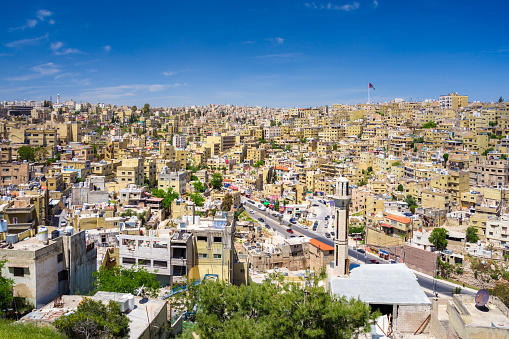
332;177;351;276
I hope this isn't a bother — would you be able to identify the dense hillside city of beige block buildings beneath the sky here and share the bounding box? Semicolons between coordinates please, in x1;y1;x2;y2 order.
0;93;509;338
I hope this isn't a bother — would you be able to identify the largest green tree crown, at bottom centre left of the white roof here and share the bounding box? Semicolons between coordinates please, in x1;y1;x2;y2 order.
178;274;378;339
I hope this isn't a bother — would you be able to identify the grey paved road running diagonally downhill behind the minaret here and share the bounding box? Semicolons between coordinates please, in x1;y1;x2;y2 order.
242;198;474;297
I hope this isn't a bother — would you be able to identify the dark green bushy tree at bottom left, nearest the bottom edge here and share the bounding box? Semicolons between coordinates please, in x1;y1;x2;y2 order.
54;298;129;339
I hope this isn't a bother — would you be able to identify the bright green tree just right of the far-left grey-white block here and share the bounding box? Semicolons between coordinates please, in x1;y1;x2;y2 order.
92;265;159;298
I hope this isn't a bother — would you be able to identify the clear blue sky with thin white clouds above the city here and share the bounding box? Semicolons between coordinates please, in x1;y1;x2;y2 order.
0;0;509;107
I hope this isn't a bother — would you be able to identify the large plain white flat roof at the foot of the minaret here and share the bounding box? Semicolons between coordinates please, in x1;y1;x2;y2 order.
330;264;431;305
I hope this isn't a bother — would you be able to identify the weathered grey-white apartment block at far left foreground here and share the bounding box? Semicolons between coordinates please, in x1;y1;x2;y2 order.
0;229;97;308
